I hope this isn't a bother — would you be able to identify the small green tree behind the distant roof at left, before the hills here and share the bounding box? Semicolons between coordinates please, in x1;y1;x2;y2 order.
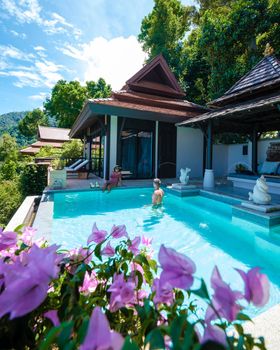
18;108;49;137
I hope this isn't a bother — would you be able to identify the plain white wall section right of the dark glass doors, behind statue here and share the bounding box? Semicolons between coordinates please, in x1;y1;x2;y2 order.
176;127;203;177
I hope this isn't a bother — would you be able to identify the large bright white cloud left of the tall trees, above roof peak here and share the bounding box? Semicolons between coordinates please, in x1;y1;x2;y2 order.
57;36;145;90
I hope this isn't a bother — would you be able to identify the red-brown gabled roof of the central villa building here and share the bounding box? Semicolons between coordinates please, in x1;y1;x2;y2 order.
69;55;208;137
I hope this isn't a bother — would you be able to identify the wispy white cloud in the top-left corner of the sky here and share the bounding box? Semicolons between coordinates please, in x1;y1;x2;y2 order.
1;0;81;38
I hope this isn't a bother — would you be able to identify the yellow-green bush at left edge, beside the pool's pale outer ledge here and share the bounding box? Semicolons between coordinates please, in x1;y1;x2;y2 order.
0;180;23;227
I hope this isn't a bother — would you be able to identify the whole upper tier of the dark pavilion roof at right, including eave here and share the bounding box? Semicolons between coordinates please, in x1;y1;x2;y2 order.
209;55;280;107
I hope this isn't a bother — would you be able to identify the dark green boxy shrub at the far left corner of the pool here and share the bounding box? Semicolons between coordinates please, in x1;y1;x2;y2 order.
20;163;47;196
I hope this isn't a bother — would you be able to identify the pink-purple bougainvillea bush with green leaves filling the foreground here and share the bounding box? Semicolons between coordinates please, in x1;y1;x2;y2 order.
0;224;269;350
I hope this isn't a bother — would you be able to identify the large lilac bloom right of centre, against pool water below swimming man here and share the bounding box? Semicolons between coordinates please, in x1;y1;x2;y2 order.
158;244;196;289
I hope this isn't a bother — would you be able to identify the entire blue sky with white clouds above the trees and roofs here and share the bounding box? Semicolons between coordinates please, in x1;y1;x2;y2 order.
0;0;193;114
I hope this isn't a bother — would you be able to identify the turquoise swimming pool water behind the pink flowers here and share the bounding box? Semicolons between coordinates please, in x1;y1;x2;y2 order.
52;189;280;316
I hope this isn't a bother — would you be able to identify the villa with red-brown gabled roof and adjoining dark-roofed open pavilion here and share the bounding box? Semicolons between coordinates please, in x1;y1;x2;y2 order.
69;55;280;193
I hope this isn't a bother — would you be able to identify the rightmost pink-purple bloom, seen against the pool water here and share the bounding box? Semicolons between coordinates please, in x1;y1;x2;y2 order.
236;267;269;307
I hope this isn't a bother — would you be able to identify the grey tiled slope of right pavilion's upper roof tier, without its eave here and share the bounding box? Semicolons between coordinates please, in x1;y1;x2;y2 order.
225;56;280;95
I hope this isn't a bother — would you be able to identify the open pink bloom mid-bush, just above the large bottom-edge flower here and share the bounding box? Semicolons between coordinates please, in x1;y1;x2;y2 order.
108;274;135;312
